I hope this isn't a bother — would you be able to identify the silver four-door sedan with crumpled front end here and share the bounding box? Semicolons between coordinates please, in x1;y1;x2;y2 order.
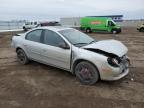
12;27;129;85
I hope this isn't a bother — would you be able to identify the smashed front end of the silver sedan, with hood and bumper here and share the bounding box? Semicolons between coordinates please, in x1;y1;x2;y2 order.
82;40;130;80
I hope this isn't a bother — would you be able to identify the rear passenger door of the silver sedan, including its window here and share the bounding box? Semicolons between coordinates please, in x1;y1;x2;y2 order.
23;29;43;61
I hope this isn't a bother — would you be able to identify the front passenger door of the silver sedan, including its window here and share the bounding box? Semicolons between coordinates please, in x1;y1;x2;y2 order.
42;30;71;70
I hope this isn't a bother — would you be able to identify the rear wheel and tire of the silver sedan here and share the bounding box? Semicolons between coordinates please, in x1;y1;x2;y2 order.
16;49;29;65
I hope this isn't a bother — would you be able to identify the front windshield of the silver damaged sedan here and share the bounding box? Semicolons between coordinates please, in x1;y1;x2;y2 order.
59;29;95;47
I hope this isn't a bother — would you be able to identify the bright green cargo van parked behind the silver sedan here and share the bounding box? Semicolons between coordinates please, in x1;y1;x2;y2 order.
81;17;121;34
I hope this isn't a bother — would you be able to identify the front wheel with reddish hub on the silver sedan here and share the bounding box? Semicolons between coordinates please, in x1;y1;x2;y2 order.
75;61;99;85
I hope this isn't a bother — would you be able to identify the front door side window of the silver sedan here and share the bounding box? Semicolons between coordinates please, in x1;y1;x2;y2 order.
44;30;64;46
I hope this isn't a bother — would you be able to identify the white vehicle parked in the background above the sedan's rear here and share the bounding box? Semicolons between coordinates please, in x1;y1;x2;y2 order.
23;22;39;31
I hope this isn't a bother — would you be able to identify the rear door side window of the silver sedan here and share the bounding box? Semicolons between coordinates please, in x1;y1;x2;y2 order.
26;30;42;42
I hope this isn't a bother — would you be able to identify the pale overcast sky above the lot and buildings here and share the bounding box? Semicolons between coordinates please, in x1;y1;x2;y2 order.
0;0;144;20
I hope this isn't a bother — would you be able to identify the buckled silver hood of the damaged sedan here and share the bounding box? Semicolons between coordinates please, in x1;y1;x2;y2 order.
83;40;128;57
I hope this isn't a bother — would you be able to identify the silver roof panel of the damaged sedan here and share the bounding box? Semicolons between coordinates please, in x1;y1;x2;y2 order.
36;26;73;32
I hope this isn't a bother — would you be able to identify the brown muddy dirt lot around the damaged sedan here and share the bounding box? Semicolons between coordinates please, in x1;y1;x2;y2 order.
0;28;144;108
